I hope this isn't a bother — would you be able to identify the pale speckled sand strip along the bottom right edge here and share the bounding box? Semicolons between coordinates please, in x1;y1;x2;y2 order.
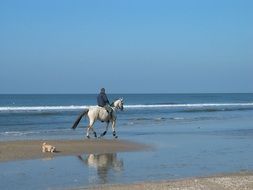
76;173;253;190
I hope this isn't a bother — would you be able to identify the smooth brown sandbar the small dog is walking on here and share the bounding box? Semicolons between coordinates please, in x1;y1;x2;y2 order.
0;139;148;162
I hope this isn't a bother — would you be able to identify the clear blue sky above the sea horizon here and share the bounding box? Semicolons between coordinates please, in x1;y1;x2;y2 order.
0;0;253;93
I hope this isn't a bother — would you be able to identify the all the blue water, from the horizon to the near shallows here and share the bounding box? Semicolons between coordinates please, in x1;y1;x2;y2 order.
0;93;253;189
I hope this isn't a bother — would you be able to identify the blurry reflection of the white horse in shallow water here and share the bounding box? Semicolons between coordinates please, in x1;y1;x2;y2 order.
78;153;123;183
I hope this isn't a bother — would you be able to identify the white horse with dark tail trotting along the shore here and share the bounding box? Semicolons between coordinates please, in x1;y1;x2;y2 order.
72;98;124;138
